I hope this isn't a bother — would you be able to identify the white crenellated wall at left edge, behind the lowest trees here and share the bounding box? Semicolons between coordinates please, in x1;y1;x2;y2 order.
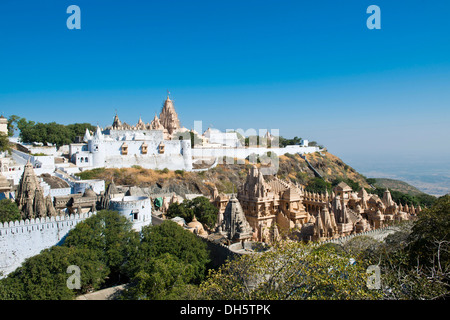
0;212;94;276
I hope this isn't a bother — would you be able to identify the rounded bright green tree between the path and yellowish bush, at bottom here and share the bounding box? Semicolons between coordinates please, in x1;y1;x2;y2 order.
124;220;210;299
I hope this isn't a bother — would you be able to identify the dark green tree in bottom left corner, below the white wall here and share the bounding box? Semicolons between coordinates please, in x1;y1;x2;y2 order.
0;246;109;300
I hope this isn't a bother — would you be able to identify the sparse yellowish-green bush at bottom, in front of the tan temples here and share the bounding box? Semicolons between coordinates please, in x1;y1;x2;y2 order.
200;242;381;300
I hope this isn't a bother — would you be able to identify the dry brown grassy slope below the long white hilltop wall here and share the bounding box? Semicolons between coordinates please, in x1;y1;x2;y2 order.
76;152;369;195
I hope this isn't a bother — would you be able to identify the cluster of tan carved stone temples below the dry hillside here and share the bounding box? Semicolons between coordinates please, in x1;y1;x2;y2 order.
227;165;419;242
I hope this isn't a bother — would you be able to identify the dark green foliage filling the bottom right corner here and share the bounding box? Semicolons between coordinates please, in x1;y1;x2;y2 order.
344;195;450;300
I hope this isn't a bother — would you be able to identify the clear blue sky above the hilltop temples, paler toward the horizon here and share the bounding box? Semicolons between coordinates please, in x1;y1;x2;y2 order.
0;0;450;176
